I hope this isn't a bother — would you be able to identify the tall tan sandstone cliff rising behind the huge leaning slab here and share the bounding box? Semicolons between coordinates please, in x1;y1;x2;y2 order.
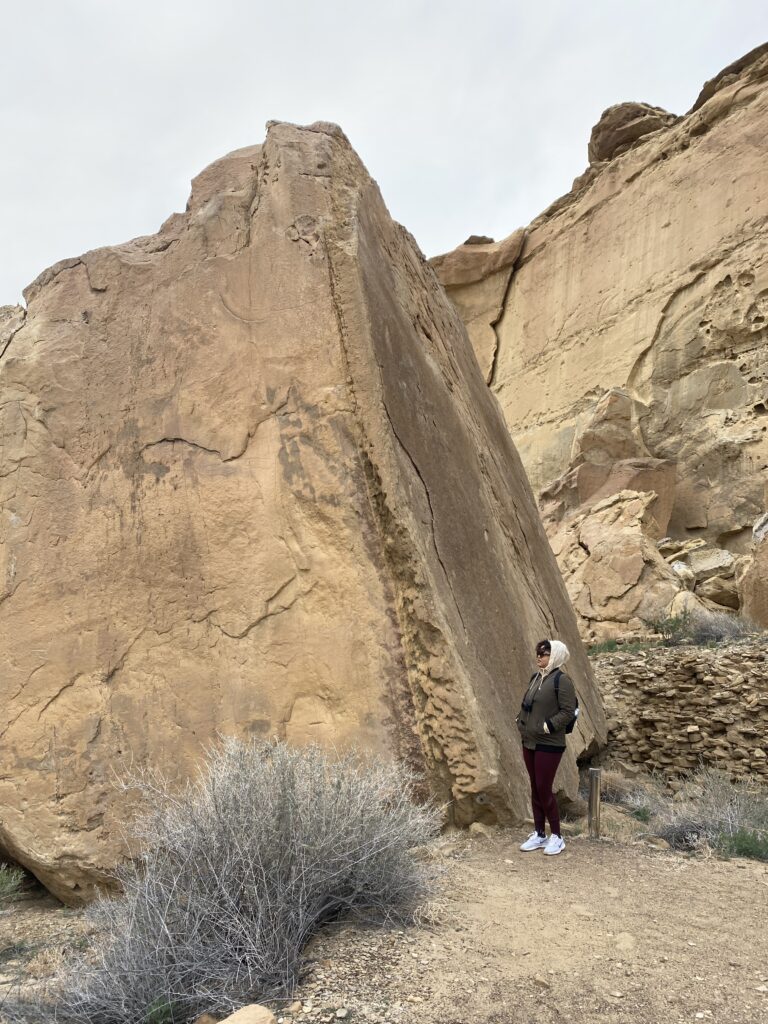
435;46;768;632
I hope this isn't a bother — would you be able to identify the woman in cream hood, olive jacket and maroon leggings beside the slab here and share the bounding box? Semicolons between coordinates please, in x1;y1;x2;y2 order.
517;640;579;855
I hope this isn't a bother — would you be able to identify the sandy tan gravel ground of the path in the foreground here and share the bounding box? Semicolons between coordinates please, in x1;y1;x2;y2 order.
0;830;768;1024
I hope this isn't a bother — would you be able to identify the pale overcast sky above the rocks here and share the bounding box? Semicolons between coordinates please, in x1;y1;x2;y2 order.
0;0;768;304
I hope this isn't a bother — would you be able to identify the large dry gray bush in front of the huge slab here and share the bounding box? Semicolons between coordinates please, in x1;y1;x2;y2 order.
3;739;440;1024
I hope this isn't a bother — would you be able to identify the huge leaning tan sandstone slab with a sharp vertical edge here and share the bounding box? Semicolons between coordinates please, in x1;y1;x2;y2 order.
0;124;604;902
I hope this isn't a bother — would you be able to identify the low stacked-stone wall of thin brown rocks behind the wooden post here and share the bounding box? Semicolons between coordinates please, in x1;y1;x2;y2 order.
594;640;768;783
